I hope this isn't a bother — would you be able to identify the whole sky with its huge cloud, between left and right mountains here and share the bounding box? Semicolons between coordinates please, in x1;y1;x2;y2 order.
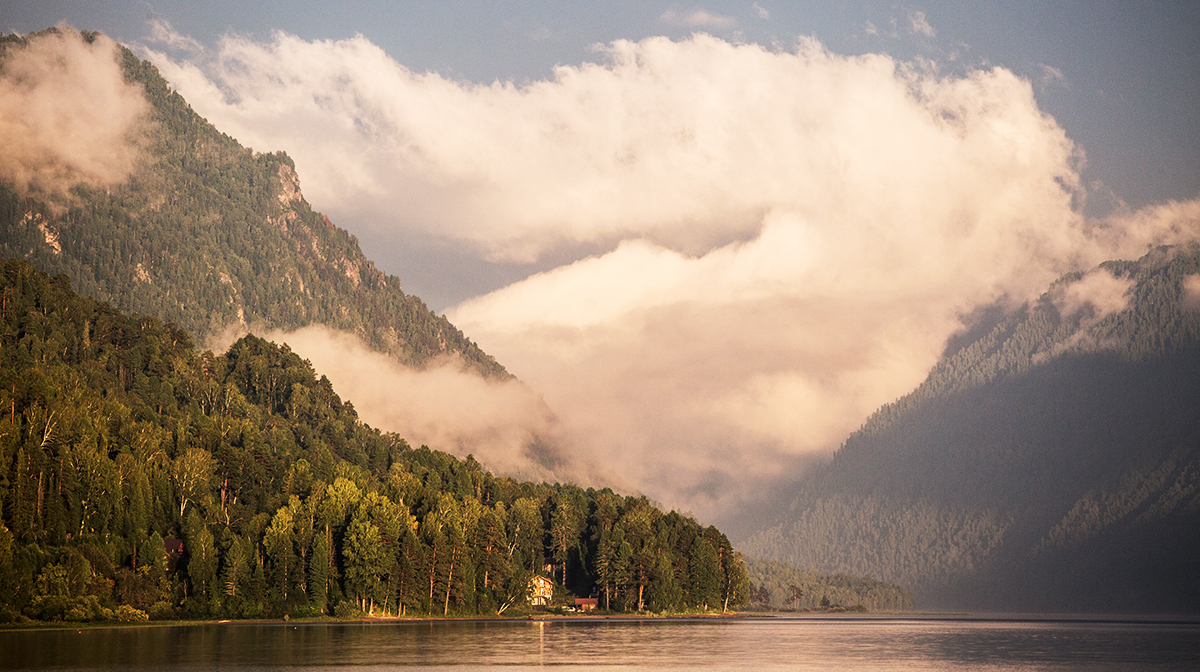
0;0;1200;518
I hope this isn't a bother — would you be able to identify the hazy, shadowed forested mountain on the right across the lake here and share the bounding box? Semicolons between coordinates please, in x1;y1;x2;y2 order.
743;246;1200;613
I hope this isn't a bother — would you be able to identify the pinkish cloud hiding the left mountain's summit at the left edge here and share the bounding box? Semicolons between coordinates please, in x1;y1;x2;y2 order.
0;28;149;204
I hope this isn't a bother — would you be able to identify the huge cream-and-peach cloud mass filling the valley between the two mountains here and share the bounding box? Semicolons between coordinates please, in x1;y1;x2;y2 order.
150;34;1200;518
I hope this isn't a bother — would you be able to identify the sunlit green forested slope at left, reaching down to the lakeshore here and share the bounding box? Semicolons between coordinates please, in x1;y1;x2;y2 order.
0;260;748;622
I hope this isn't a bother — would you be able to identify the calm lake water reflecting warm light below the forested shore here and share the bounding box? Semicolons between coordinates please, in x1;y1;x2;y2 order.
0;617;1200;672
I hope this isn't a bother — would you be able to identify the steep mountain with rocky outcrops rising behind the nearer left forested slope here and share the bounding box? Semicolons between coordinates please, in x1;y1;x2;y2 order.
0;32;508;377
